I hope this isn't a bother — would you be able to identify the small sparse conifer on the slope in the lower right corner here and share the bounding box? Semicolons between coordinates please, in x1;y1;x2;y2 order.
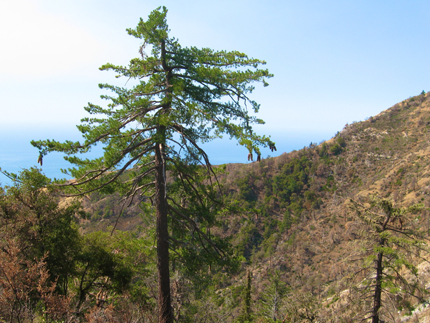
349;198;427;323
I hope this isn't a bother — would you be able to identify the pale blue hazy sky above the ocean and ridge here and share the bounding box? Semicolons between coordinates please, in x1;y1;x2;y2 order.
0;0;430;184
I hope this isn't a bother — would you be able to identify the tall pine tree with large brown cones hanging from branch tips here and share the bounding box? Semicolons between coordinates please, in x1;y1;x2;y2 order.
32;7;274;322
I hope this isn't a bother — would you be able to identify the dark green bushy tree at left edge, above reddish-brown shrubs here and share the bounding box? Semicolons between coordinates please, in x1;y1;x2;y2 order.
0;168;85;295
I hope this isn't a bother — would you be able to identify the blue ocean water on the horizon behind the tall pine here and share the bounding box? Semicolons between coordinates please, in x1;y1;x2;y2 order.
0;127;334;186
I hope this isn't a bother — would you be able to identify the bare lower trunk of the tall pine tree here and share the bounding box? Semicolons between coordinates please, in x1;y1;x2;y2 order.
155;144;173;323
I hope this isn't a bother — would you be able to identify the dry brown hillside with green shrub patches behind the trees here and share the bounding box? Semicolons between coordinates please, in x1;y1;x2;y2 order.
71;90;430;322
